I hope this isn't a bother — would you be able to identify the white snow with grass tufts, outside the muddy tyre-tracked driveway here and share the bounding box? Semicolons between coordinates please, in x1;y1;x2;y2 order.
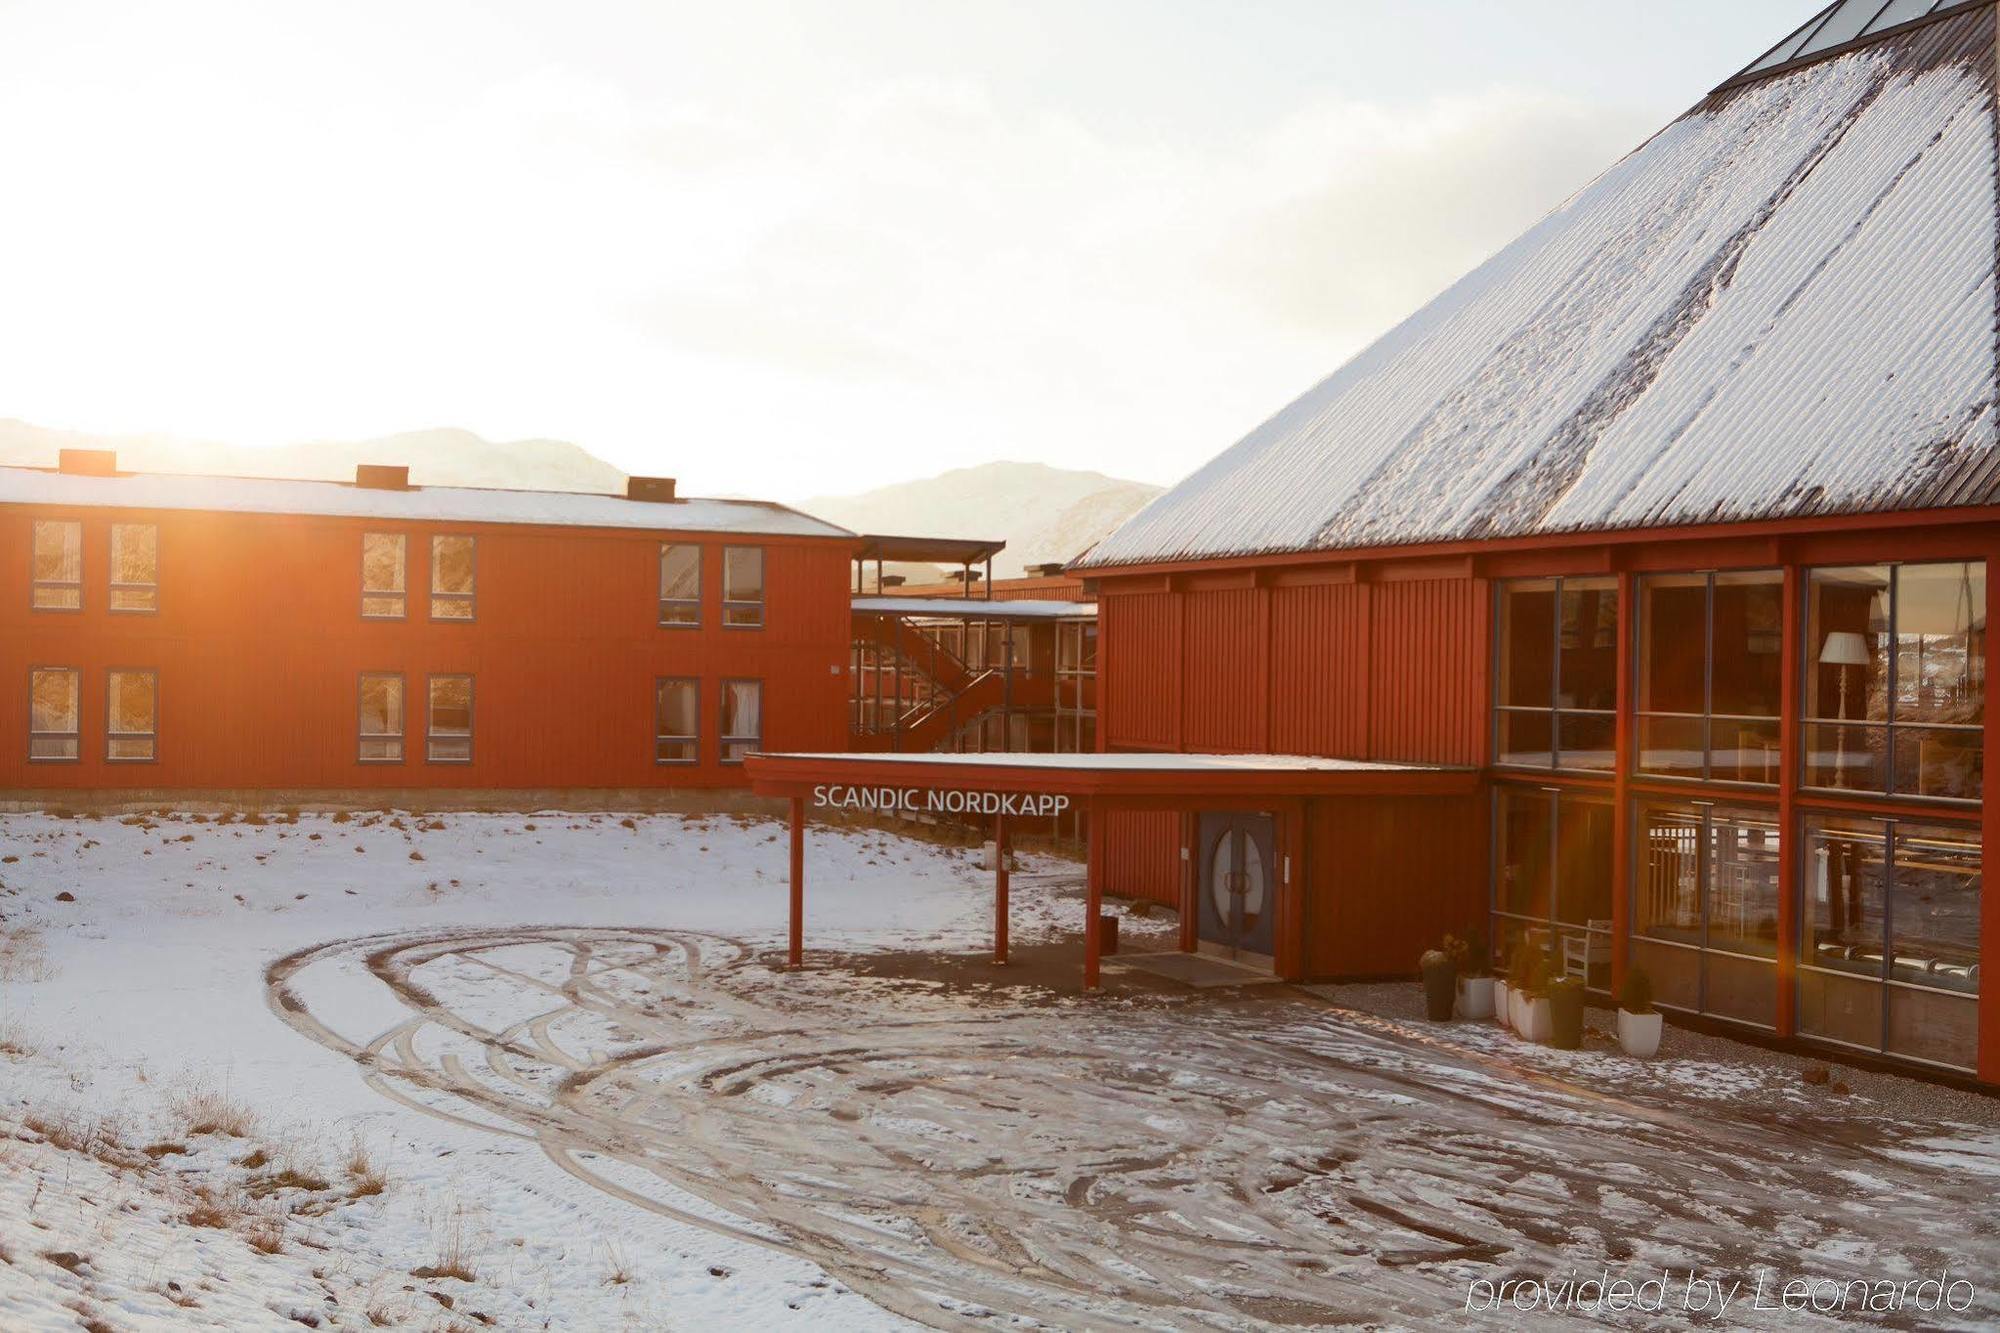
0;815;1112;1333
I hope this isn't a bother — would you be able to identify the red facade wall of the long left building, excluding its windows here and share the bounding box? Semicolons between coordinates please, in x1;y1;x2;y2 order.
0;508;850;789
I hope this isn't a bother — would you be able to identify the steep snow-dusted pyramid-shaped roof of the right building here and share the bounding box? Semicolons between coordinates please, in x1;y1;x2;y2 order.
1082;0;2000;568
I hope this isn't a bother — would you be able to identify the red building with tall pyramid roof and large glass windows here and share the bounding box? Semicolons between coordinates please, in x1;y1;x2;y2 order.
1072;0;2000;1083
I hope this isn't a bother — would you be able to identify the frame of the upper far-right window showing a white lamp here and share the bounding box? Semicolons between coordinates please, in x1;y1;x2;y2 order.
1786;556;1992;804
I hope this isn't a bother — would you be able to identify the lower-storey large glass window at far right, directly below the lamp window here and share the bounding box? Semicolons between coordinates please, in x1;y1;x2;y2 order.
1798;815;1982;1069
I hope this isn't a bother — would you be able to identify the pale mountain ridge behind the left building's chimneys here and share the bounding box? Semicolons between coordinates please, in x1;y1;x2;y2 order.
0;420;624;492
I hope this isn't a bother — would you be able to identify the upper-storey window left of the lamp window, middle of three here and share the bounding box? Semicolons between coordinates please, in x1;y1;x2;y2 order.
1638;568;1784;785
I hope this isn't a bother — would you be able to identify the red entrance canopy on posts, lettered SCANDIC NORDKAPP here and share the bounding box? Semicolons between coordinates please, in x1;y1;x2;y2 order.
744;753;1476;991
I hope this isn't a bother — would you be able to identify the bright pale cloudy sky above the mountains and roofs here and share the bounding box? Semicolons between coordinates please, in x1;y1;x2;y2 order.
0;0;1818;498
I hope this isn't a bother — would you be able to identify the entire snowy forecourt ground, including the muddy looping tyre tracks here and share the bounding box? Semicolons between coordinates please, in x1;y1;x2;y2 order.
0;815;2000;1331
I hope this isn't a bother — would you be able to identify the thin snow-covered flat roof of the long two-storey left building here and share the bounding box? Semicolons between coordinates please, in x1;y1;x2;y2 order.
0;466;854;538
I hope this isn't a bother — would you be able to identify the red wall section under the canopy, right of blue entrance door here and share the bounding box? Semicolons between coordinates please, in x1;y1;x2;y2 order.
1304;797;1486;979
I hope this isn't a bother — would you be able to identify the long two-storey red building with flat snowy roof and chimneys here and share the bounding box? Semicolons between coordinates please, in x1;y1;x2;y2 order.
0;450;856;803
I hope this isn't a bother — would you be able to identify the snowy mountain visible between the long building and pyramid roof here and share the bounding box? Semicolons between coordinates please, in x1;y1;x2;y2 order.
800;462;1162;578
